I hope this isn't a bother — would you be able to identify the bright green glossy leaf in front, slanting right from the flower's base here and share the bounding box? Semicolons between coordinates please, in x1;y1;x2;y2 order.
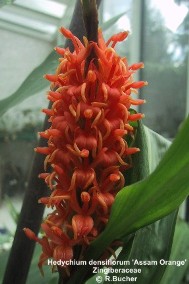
68;118;189;284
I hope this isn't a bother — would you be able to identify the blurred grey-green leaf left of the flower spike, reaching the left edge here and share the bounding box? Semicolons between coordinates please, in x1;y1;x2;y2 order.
0;51;58;116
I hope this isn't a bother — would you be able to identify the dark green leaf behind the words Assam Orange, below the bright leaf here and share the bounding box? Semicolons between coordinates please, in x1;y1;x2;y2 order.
114;211;177;284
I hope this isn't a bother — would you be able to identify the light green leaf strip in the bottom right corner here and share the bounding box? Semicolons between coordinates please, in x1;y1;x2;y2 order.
160;220;189;284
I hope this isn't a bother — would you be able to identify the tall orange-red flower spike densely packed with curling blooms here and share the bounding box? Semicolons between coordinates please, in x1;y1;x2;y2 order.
25;28;147;272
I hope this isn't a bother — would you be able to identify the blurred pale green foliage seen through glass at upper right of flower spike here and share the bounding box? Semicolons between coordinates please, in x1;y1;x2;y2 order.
142;1;189;138
